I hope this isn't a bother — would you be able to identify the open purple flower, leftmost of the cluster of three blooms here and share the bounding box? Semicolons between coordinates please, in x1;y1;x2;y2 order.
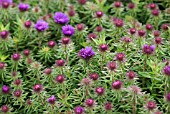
34;20;49;32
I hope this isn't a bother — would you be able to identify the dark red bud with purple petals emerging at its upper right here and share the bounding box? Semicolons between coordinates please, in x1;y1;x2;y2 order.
142;44;156;55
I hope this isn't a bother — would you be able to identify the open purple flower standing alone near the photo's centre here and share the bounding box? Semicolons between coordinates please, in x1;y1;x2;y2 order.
78;47;95;61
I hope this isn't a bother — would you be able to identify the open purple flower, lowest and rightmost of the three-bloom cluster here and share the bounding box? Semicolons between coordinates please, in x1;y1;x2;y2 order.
62;25;74;36
